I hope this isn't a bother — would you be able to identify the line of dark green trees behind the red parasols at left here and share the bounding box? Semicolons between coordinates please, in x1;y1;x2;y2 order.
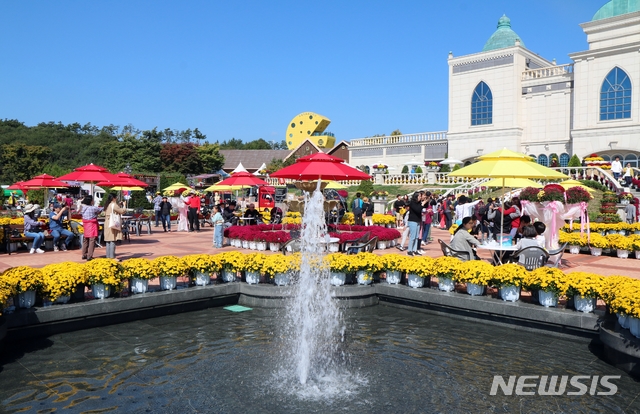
0;119;286;184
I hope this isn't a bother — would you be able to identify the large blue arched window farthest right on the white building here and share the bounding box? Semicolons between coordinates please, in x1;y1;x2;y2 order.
600;67;631;121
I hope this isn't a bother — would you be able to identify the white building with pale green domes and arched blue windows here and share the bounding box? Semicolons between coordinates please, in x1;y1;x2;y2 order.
350;0;640;167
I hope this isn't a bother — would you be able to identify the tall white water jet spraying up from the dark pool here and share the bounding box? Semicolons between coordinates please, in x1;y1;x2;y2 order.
277;181;365;397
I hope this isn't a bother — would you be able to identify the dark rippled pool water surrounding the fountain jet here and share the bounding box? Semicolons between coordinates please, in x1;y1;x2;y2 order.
0;306;640;413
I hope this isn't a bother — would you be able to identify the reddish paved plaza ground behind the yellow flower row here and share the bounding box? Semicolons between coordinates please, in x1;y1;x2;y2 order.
6;223;640;279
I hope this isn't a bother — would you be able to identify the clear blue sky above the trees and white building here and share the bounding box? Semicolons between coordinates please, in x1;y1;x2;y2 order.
0;0;606;142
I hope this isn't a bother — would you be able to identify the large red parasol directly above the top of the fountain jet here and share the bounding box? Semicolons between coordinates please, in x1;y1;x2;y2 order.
271;152;371;181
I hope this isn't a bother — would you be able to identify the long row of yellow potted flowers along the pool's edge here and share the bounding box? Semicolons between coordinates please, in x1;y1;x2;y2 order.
0;252;640;317
